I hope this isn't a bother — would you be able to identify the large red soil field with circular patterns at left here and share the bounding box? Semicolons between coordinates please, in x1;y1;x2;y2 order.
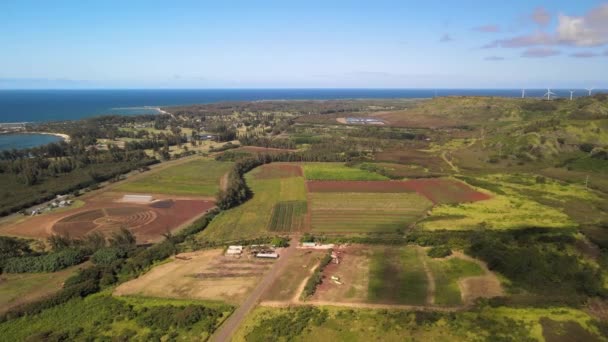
0;198;215;244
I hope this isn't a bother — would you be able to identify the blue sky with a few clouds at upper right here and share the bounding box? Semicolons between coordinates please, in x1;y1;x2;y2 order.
0;0;608;89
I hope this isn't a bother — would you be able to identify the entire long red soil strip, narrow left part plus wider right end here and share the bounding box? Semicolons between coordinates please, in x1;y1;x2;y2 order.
306;178;491;204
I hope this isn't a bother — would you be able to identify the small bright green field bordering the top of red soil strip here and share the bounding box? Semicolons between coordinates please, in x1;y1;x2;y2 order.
303;163;388;181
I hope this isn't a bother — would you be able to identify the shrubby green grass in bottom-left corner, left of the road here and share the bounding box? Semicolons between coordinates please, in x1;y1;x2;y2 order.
0;291;232;341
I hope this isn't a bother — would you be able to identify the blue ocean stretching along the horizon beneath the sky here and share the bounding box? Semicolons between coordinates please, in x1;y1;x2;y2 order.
0;89;600;122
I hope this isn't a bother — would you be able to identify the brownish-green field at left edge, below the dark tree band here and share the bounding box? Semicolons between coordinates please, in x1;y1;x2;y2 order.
0;264;87;314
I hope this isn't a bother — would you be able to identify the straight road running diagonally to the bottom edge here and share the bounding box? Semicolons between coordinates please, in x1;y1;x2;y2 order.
211;237;298;342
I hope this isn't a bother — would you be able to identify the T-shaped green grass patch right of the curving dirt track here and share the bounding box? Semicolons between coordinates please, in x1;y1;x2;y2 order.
428;258;485;306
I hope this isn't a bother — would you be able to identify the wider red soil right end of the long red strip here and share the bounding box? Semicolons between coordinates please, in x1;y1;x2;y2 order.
403;178;491;204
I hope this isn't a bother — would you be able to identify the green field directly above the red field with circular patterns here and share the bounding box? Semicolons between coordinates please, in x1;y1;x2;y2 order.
116;159;232;196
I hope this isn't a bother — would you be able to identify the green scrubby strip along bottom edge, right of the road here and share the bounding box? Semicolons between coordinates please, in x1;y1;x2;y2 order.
233;307;603;342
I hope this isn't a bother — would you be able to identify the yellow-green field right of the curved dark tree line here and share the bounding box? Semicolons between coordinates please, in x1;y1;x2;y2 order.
199;166;306;241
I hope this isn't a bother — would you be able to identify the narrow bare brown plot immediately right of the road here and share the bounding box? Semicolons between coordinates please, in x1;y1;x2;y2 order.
262;249;326;301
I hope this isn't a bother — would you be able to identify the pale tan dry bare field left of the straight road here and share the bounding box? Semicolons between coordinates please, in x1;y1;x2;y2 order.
114;249;273;304
